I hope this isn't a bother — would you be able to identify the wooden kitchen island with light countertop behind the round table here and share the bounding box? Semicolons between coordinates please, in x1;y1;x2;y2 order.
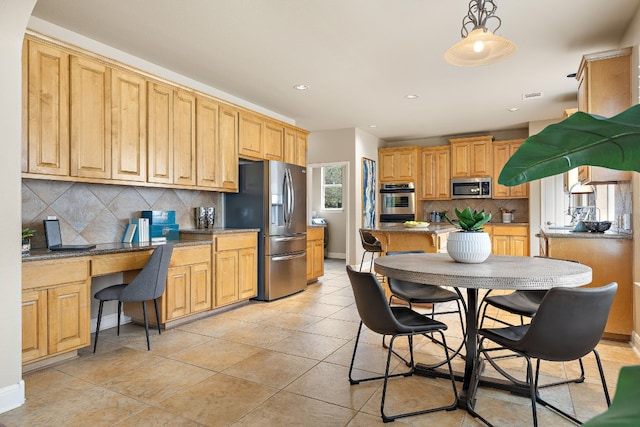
364;223;458;253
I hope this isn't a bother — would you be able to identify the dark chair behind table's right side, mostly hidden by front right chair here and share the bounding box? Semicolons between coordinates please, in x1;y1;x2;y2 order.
479;255;584;388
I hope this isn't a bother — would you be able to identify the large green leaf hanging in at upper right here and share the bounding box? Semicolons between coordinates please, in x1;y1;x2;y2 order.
498;104;640;186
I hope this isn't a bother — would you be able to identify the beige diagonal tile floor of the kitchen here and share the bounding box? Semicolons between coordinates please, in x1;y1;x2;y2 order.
0;260;640;427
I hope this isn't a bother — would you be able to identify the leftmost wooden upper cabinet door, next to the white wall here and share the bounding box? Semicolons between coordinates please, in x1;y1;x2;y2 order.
24;40;69;176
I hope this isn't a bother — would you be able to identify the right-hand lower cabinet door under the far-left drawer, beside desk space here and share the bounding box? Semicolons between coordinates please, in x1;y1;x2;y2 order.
47;282;91;354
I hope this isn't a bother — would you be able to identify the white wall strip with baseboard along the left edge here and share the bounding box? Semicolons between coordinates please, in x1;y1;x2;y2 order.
0;0;36;413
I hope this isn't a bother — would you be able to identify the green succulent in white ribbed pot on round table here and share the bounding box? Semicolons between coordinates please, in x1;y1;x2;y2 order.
444;206;492;264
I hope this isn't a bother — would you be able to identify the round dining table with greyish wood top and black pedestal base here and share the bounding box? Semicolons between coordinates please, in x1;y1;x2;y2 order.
374;253;591;418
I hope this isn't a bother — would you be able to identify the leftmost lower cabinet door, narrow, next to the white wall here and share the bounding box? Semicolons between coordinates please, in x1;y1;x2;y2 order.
22;290;48;363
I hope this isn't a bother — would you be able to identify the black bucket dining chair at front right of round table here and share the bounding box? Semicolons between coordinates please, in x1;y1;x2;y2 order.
478;282;618;426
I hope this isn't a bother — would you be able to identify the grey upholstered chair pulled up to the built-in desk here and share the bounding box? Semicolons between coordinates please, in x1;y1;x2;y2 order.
93;243;173;353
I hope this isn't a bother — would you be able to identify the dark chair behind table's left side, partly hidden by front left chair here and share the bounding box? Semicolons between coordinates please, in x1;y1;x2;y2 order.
382;250;467;368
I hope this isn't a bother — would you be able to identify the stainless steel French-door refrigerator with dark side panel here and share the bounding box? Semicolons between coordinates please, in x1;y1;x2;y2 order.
224;160;307;301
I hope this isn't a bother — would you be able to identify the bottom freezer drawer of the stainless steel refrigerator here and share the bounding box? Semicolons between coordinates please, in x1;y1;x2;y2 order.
263;252;307;301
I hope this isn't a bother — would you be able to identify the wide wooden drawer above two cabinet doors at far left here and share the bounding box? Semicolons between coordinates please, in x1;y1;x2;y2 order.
22;258;89;289
